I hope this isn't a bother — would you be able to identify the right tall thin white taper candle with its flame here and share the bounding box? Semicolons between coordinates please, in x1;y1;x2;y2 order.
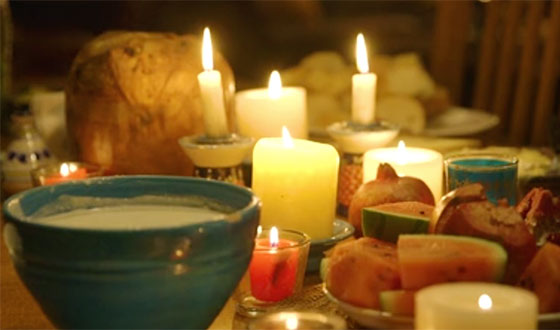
352;33;377;124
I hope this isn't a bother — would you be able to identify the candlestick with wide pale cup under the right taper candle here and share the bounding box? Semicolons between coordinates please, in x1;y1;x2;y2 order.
327;121;399;217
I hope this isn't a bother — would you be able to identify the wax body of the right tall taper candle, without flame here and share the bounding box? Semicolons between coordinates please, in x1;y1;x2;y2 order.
352;73;377;124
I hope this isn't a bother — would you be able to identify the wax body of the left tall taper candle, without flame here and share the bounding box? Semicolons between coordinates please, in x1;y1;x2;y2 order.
198;70;229;137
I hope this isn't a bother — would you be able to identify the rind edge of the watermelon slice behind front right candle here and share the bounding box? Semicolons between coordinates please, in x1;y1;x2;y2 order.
397;234;508;282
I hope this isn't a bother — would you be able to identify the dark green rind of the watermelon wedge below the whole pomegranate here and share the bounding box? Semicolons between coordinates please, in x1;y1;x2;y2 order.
362;207;430;243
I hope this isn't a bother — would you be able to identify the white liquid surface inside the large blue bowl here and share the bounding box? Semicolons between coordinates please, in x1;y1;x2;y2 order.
34;205;223;230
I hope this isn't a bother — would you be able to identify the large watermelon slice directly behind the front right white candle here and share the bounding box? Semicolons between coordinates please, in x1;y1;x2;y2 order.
397;235;507;290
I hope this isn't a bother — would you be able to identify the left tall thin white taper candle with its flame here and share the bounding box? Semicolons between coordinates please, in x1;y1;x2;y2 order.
198;28;229;137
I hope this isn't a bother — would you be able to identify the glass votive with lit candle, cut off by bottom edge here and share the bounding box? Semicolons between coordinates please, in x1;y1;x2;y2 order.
249;312;346;330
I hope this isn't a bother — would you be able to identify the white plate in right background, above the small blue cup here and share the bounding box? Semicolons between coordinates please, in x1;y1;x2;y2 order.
424;107;500;136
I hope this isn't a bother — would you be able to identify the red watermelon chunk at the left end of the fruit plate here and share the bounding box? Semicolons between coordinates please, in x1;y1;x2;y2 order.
325;237;400;309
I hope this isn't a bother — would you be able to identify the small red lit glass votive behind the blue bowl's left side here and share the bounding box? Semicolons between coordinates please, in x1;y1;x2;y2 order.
31;162;104;187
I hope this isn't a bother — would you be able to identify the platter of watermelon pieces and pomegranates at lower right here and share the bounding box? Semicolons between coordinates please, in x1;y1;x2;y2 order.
321;165;560;329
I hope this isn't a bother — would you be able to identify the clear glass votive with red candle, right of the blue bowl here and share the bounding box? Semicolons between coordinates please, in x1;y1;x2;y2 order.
235;227;311;317
